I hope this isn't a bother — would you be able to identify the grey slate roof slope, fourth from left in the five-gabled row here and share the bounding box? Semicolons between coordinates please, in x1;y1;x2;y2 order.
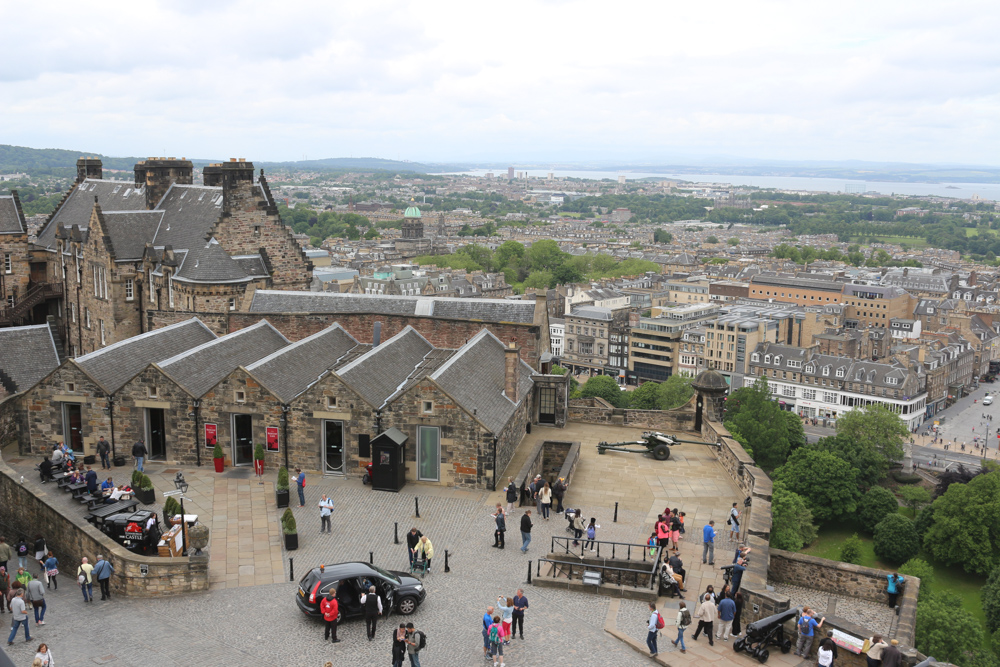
337;326;434;408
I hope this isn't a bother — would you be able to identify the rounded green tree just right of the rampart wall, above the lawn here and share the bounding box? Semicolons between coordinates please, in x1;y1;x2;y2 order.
774;448;860;524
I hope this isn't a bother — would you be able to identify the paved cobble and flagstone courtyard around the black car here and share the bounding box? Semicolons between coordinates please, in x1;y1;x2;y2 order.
5;424;812;667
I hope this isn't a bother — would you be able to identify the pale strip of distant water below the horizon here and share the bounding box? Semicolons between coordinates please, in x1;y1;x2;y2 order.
438;169;1000;200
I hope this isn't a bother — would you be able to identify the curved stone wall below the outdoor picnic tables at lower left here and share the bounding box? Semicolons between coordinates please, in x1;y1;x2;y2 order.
0;462;208;598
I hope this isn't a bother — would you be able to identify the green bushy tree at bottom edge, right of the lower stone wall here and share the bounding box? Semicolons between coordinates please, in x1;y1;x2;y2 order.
916;591;983;665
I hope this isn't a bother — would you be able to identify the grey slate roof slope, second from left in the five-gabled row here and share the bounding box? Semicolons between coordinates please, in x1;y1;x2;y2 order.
158;320;289;398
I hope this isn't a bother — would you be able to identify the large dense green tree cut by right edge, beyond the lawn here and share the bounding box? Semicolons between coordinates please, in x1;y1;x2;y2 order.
921;471;1000;576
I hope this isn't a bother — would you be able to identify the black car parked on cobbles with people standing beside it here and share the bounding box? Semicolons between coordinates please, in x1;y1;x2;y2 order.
295;562;427;621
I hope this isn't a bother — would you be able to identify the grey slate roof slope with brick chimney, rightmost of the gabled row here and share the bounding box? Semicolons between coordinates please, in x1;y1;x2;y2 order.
431;329;532;435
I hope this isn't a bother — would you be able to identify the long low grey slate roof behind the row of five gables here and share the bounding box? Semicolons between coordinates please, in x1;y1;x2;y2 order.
250;290;535;324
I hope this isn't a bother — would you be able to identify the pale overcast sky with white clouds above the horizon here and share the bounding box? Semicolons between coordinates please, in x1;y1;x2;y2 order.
0;0;1000;165
